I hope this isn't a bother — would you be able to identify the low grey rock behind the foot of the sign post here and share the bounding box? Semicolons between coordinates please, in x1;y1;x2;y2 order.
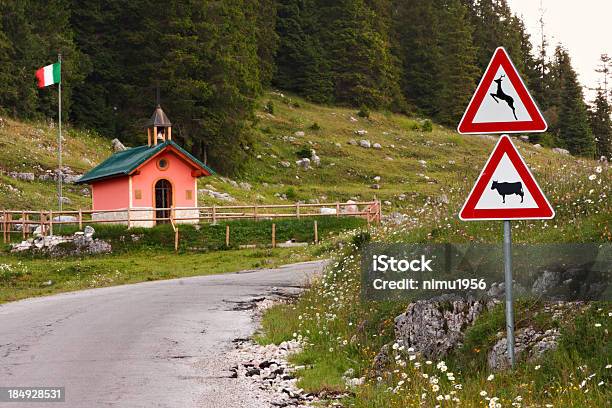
487;326;559;371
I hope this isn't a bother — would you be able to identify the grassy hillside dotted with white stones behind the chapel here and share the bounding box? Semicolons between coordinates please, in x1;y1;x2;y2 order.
0;92;597;222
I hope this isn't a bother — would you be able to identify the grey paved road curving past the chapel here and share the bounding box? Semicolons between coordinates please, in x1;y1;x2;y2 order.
0;261;323;408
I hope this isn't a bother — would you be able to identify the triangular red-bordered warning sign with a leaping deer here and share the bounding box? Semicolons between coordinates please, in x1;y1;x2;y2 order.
457;47;548;134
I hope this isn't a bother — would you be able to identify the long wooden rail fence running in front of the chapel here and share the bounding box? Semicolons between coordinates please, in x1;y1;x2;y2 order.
0;201;381;243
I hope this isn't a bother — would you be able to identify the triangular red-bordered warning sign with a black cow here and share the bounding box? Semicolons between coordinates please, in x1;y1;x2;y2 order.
459;135;555;221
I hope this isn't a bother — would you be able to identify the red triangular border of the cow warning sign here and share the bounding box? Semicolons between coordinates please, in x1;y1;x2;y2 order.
459;135;555;221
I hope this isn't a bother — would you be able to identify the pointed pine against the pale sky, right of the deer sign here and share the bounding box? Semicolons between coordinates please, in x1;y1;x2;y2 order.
558;48;595;157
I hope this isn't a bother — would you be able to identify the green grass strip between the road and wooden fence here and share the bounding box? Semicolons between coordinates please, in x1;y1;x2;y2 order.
0;248;311;303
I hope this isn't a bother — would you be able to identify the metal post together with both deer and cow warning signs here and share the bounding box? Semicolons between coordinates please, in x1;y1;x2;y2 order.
457;47;555;368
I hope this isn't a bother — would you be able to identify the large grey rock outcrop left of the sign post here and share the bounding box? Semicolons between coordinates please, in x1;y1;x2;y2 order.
395;294;486;359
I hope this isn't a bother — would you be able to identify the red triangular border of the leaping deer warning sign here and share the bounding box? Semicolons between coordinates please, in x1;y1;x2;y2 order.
457;47;548;135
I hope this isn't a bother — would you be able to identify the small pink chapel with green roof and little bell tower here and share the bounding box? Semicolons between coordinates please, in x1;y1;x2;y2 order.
77;105;214;227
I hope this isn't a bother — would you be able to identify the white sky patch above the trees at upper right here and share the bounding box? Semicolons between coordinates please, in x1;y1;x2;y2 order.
508;0;612;102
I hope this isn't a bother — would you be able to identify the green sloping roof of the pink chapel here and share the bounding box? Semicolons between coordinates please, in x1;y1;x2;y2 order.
76;140;215;184
